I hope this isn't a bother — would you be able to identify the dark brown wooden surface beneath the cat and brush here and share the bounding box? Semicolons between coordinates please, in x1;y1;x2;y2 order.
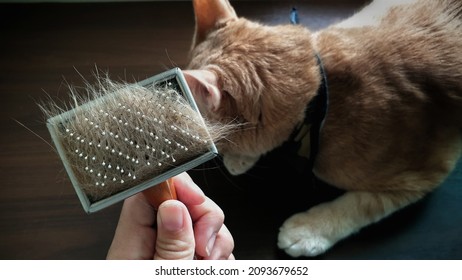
0;0;462;259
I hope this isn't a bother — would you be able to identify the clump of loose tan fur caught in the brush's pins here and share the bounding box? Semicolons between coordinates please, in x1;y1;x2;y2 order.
41;75;232;202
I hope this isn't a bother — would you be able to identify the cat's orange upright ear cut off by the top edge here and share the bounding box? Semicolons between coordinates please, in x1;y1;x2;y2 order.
192;0;237;48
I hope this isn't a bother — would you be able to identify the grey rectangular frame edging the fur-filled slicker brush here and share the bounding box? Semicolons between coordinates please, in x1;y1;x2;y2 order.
47;67;218;213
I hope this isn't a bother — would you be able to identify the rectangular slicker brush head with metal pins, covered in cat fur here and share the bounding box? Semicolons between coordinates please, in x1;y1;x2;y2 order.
45;68;217;213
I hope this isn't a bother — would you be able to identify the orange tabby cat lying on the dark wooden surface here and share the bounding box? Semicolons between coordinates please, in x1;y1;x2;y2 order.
186;0;462;256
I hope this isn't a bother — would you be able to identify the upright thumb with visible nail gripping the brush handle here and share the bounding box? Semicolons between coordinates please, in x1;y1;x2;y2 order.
154;200;196;260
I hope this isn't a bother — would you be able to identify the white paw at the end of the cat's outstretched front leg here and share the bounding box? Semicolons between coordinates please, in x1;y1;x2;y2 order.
278;213;334;258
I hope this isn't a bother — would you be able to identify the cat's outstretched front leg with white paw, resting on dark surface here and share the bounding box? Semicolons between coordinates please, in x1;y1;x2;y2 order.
278;191;423;257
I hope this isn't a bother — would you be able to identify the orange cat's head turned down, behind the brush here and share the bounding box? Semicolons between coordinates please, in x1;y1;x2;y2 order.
184;0;319;174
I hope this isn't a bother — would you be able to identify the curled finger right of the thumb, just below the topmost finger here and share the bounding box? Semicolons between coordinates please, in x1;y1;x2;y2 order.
189;198;225;257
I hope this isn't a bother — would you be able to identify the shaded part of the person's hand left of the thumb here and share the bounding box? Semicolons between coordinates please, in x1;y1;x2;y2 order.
107;194;156;259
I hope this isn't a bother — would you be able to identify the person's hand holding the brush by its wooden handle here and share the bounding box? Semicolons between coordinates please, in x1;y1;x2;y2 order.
107;173;234;260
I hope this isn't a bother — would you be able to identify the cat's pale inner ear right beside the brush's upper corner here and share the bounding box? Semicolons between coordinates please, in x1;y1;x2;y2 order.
183;70;221;112
